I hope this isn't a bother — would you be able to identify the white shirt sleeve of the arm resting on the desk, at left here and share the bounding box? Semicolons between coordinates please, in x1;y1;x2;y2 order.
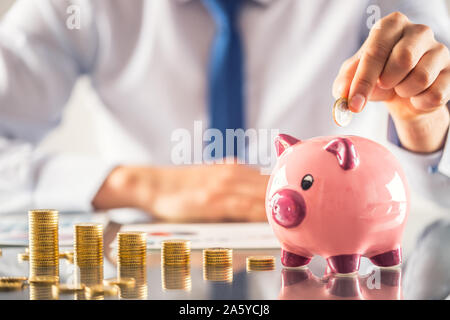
0;0;111;212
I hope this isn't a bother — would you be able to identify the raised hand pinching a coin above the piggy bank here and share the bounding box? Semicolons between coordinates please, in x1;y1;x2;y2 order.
333;12;450;152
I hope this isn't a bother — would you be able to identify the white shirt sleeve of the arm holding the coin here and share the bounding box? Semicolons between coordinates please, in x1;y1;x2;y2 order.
363;0;450;207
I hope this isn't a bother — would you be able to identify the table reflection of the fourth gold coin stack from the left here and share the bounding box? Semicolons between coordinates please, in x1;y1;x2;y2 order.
161;265;192;291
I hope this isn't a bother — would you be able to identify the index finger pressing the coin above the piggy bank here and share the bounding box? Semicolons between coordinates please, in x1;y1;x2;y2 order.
349;13;408;112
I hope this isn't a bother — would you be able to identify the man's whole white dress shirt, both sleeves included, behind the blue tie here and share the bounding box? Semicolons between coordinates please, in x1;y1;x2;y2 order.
0;0;450;212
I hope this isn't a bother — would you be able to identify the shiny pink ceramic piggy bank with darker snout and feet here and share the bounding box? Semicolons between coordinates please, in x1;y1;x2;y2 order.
266;134;410;273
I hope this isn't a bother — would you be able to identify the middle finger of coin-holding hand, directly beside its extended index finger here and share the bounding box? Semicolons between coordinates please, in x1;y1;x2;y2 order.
379;24;435;89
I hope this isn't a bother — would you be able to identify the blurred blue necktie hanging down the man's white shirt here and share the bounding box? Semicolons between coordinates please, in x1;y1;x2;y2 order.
202;0;245;156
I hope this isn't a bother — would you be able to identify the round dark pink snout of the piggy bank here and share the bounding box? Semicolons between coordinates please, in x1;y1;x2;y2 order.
271;189;306;228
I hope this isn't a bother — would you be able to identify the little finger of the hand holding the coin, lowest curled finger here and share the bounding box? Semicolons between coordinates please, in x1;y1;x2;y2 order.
411;68;450;111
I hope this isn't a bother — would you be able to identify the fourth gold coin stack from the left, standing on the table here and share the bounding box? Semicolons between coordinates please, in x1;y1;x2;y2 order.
161;240;191;266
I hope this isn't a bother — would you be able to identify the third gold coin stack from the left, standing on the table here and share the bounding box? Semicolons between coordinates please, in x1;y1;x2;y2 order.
117;231;147;266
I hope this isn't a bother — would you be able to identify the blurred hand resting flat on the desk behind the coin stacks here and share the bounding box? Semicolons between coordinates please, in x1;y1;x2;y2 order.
93;164;269;222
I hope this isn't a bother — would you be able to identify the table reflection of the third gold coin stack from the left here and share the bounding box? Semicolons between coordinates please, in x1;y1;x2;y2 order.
117;265;148;300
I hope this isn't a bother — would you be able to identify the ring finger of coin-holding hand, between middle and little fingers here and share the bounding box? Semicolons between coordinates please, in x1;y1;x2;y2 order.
395;44;449;98
